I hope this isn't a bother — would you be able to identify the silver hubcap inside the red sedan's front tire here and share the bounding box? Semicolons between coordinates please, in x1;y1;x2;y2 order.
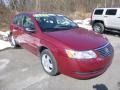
42;54;53;72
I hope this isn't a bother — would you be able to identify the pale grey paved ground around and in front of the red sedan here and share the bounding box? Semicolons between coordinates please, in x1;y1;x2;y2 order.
0;31;120;90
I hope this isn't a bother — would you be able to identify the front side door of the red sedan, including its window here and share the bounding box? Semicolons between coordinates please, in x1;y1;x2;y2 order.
22;15;39;54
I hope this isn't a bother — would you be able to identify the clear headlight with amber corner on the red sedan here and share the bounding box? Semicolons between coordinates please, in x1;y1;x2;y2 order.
65;50;97;59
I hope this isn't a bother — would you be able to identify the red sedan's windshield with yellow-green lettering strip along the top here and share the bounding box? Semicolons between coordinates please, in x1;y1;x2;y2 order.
33;14;78;32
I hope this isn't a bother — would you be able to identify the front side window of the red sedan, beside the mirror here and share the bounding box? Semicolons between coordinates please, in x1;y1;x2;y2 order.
23;16;35;30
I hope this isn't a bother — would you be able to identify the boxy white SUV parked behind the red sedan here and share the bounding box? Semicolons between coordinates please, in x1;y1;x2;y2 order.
91;8;120;33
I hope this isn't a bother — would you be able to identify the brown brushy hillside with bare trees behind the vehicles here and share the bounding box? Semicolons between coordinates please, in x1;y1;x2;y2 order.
0;0;120;30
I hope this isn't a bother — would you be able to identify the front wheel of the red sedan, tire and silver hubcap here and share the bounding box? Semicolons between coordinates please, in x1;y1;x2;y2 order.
40;49;59;76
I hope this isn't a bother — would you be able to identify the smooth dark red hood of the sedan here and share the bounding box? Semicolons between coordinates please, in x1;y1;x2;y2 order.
46;28;108;50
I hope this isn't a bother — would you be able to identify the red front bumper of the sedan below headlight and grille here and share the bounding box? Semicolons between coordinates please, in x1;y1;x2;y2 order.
58;55;113;79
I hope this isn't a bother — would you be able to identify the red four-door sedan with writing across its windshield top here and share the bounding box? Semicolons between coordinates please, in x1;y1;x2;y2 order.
9;12;114;79
